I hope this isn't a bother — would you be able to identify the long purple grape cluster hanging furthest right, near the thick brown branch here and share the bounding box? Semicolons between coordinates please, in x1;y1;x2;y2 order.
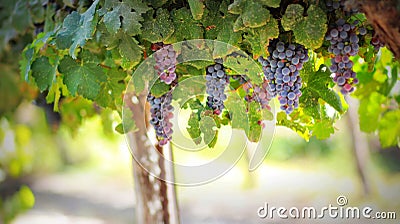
325;19;359;94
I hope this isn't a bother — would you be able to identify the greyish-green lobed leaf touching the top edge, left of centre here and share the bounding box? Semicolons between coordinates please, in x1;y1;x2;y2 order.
103;0;150;36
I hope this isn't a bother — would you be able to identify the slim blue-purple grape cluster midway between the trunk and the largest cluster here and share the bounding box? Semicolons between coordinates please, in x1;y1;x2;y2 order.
206;62;229;115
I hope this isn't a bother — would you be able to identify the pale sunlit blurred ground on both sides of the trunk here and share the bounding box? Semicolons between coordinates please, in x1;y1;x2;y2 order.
10;155;400;224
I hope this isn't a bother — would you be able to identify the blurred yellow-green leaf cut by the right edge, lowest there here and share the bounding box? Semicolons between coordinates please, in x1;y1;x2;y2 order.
379;110;400;148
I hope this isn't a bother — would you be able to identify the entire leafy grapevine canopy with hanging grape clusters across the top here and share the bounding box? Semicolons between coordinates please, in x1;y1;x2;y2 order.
0;0;400;222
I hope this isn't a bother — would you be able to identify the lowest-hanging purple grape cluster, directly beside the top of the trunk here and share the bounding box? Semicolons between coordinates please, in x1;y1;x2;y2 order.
147;91;174;146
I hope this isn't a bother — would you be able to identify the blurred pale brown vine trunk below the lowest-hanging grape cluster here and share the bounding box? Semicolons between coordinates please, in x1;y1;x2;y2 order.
125;94;180;224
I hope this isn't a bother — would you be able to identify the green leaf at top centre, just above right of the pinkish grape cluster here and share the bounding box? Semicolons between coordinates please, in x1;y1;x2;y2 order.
165;8;203;43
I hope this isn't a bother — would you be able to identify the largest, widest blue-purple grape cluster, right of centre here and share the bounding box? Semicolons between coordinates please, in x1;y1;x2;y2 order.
258;39;309;114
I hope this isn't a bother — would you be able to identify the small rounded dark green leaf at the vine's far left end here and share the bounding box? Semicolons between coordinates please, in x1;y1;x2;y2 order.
32;56;56;92
